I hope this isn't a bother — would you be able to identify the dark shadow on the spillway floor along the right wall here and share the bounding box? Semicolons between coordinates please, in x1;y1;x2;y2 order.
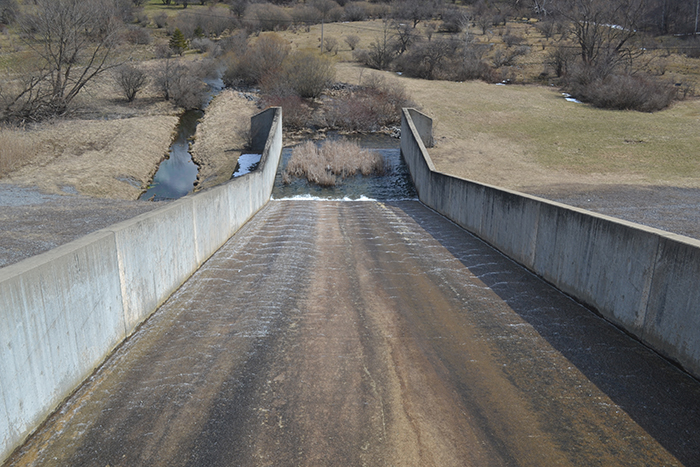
393;203;700;466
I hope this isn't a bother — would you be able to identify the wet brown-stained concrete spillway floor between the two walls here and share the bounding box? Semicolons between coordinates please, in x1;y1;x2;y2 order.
8;201;700;467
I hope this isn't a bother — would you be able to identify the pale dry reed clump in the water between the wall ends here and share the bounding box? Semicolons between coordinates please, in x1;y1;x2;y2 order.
283;140;386;186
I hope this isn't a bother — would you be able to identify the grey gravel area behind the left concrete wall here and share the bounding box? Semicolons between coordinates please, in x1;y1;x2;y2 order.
0;184;161;267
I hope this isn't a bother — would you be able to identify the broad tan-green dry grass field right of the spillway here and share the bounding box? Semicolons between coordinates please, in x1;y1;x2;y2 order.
338;63;700;190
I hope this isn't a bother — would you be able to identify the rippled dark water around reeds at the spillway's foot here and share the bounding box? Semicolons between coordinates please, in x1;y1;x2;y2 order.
272;136;418;201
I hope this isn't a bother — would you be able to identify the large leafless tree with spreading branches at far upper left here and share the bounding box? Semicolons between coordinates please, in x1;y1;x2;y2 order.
0;0;123;120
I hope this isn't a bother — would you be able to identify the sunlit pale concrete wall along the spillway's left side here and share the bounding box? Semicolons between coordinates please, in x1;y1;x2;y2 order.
0;108;282;461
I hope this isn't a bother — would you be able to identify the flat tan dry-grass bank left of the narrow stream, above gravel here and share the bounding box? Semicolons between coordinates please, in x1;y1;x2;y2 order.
0;115;177;200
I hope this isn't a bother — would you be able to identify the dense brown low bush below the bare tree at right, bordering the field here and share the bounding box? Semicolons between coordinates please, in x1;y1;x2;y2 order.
566;66;677;112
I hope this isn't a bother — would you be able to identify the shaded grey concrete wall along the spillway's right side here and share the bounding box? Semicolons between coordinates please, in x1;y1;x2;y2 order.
401;109;700;378
